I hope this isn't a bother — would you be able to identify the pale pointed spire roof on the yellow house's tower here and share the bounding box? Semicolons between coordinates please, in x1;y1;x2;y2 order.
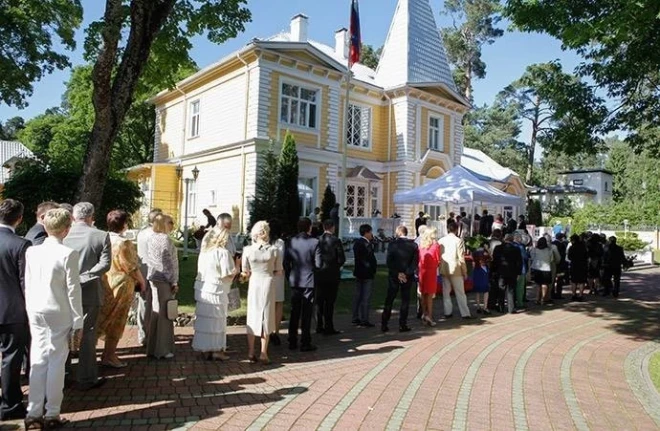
376;0;457;93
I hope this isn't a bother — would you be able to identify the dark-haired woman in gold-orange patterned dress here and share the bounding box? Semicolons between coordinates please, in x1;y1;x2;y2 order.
98;210;145;368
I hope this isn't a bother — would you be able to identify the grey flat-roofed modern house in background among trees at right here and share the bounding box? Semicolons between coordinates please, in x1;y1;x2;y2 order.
529;169;614;211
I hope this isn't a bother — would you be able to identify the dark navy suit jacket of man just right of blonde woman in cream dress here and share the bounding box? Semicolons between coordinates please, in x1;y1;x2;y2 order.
284;233;322;289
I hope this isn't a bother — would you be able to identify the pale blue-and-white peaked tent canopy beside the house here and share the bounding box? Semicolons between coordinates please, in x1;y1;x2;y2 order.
394;166;523;233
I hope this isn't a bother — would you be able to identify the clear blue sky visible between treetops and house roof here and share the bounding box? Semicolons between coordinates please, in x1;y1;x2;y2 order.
0;0;579;133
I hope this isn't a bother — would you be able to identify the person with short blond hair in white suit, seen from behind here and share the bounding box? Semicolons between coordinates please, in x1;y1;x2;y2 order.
25;209;83;429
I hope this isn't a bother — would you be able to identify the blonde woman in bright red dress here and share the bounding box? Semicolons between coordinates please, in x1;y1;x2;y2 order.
419;229;440;326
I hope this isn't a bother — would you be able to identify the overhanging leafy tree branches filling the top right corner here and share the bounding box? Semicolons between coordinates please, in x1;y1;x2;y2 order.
506;0;660;154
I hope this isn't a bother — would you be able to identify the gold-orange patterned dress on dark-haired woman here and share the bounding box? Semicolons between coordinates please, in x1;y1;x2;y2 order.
98;232;140;340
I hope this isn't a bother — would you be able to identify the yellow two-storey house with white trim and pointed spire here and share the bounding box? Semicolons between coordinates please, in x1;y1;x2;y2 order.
134;0;524;230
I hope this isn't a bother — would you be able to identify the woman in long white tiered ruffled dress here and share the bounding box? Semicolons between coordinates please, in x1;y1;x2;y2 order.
192;226;237;361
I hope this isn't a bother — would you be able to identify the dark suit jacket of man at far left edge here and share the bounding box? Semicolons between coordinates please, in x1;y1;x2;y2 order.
0;227;31;325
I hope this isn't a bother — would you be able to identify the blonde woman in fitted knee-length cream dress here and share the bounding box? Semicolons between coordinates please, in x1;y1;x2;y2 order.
242;221;282;365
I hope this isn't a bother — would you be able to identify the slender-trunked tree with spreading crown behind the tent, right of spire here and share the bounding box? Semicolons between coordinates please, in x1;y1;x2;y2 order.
498;62;607;183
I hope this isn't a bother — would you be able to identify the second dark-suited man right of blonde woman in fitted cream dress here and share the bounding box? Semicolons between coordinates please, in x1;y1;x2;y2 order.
316;220;346;335
